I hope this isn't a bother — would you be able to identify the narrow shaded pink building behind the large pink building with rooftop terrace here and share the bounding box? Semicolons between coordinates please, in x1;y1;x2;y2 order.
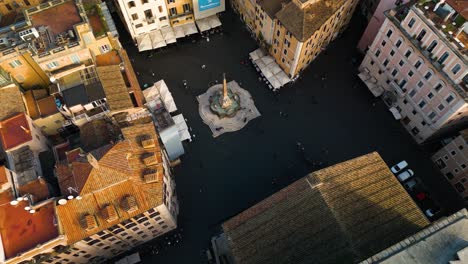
358;0;409;53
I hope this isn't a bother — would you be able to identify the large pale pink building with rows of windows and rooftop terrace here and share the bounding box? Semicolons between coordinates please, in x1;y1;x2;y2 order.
359;0;468;143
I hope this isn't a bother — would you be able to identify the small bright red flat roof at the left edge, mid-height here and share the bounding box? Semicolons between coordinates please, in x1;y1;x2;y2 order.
0;113;32;150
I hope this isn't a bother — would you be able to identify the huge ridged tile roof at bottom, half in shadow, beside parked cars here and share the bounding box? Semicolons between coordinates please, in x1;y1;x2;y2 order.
222;152;429;263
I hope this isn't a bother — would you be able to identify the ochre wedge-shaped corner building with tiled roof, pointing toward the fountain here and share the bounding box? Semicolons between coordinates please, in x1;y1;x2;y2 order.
232;0;358;78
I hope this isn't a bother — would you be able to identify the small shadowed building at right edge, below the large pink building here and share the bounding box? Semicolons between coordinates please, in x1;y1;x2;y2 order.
432;130;468;204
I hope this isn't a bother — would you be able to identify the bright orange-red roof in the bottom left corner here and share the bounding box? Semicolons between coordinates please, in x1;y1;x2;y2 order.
0;191;59;259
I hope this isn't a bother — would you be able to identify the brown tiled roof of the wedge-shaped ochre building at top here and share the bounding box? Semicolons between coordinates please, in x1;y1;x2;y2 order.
276;0;345;41
